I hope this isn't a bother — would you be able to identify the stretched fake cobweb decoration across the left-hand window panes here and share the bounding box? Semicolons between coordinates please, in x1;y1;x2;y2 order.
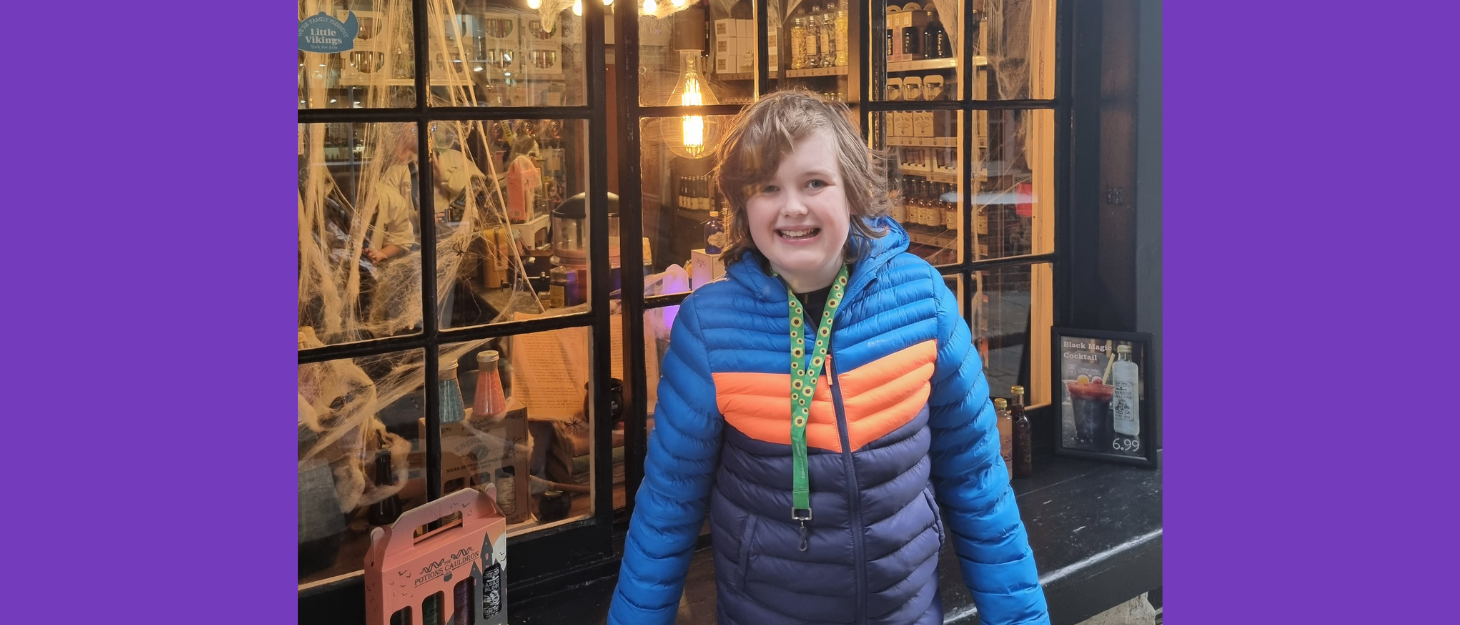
298;0;571;513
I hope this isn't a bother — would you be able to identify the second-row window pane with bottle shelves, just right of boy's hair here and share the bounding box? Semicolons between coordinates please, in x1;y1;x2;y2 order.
872;111;964;264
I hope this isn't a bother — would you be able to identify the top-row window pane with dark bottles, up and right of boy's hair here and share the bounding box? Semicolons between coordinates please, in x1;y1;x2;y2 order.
872;0;964;102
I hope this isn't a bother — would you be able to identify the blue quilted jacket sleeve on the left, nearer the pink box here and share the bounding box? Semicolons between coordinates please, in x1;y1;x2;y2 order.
609;296;723;625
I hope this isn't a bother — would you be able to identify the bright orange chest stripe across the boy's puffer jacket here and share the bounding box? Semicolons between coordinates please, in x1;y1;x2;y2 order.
714;340;937;451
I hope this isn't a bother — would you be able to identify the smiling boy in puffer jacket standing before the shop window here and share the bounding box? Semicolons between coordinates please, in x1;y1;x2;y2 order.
609;92;1048;625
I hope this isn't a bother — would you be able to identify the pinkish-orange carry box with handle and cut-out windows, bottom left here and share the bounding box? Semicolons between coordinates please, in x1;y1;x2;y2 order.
365;485;507;625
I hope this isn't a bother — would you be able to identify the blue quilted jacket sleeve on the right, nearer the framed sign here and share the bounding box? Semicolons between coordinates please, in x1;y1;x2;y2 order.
929;272;1050;625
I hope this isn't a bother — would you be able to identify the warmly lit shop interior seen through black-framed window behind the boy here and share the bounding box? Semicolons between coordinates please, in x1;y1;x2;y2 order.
298;0;1159;622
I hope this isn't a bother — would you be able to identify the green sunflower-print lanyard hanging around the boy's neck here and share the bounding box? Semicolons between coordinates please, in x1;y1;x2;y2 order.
785;264;847;551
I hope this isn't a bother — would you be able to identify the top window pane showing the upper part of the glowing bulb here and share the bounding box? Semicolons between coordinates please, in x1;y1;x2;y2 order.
639;0;756;107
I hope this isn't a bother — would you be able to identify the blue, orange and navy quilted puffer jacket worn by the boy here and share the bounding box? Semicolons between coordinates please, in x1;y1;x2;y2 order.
609;219;1048;625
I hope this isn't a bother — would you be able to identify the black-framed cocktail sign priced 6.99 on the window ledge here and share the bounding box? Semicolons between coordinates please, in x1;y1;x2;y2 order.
1053;327;1161;467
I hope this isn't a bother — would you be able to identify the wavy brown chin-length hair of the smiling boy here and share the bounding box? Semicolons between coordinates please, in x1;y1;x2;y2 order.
712;89;889;266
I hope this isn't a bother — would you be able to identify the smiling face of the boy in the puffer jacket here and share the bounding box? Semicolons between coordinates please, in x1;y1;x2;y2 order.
746;129;851;292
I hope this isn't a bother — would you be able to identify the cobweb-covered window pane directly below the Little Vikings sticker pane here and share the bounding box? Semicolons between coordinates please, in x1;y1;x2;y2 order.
299;124;420;349
